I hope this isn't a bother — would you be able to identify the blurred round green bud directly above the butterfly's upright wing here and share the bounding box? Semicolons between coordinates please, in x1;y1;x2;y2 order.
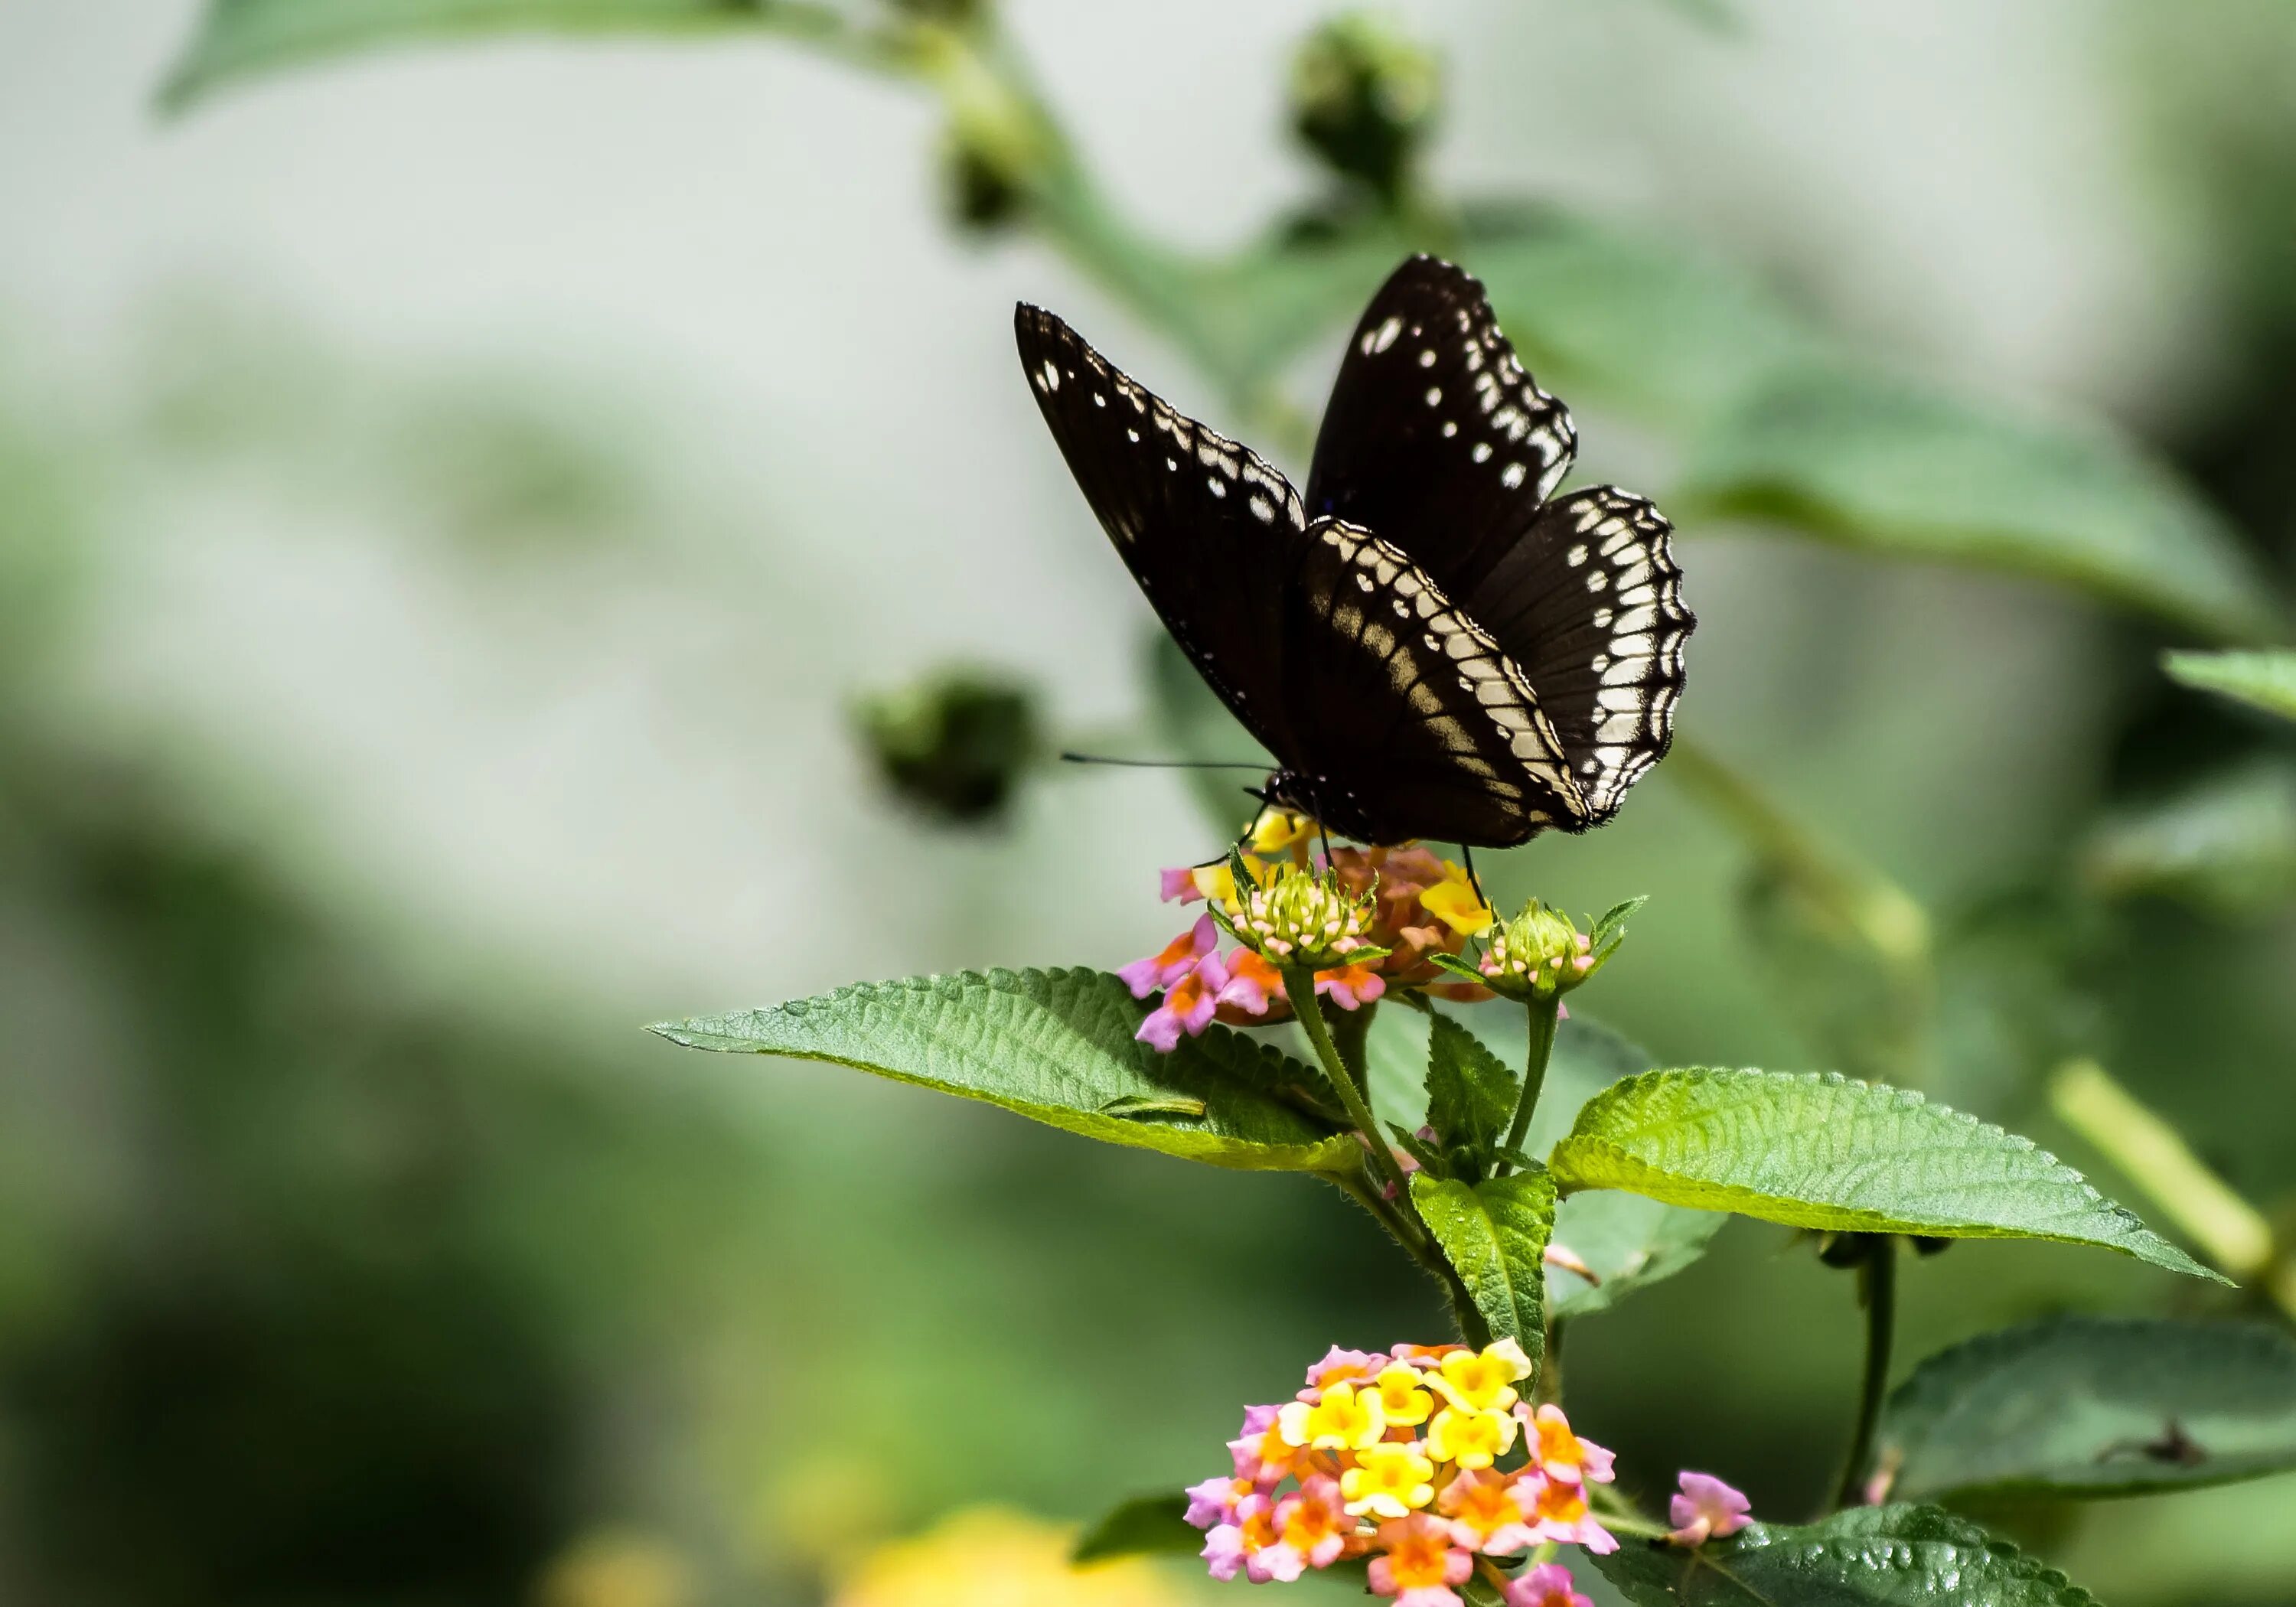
1290;14;1442;207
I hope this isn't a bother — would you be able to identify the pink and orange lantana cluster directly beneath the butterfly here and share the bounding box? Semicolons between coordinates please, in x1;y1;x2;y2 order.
1118;808;1495;1054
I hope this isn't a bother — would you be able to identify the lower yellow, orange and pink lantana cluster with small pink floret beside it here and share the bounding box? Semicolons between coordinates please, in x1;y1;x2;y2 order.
1187;1338;1747;1607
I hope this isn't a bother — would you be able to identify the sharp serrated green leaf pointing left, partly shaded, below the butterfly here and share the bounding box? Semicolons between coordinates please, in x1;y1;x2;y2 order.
652;971;1362;1171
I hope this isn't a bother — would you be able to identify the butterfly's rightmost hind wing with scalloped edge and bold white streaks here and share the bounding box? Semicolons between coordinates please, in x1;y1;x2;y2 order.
1465;487;1697;831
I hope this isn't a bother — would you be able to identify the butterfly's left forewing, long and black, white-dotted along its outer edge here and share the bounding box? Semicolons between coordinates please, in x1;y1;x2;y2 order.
1013;305;1309;767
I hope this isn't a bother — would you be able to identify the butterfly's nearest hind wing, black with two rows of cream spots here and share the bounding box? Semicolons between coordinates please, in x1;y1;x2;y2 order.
1283;519;1587;847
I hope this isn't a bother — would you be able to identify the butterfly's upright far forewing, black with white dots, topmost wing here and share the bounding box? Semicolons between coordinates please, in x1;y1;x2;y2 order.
1306;257;1577;597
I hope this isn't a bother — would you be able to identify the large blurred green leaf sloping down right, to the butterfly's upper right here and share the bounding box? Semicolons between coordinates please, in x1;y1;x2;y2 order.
1669;363;2285;641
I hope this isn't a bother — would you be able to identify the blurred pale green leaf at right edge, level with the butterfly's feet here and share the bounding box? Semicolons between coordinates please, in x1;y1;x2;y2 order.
2082;760;2296;916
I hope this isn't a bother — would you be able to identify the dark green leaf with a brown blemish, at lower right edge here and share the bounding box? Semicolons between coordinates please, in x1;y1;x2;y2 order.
1880;1318;2296;1499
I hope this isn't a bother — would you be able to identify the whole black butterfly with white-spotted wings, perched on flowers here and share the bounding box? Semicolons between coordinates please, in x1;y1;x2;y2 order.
1015;257;1694;847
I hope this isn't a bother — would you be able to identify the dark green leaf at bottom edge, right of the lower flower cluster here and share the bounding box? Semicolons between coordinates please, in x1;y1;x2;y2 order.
1593;1506;2096;1607
